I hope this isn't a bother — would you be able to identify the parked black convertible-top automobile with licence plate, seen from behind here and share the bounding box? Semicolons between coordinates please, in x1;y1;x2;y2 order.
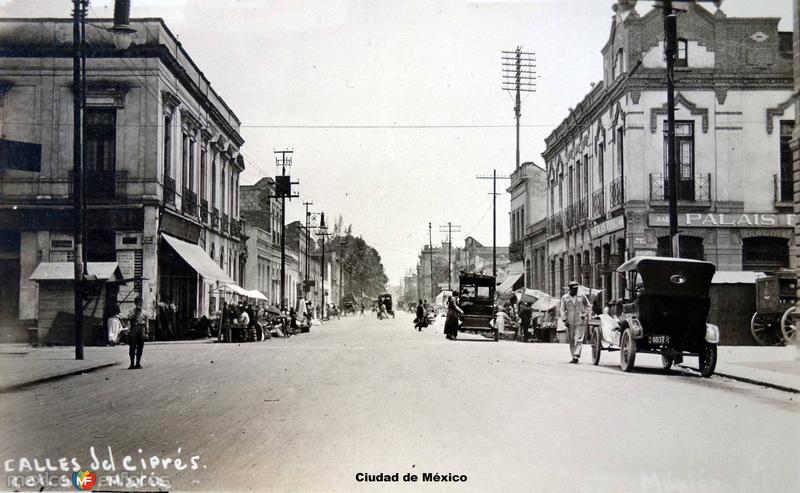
589;257;719;377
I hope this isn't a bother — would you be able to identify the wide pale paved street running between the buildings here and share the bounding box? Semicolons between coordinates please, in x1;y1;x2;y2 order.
0;313;800;492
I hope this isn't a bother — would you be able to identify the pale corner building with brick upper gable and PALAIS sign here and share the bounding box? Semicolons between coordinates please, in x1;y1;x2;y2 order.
543;2;795;297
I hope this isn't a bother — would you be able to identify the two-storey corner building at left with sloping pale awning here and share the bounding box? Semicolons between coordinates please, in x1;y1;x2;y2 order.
0;19;244;334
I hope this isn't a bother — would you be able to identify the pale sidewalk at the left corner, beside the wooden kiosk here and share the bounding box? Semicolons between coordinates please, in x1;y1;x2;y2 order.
0;344;122;394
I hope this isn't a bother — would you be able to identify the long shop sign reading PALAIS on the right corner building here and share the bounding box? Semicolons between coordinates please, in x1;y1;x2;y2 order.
647;212;797;228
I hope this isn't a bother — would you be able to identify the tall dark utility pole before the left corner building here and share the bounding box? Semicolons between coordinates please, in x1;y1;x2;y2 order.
72;0;86;360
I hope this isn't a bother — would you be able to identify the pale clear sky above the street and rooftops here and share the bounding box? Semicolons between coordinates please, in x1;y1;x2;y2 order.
0;0;792;284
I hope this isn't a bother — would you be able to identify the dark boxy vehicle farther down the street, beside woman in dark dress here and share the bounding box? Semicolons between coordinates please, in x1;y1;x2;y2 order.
458;274;500;341
